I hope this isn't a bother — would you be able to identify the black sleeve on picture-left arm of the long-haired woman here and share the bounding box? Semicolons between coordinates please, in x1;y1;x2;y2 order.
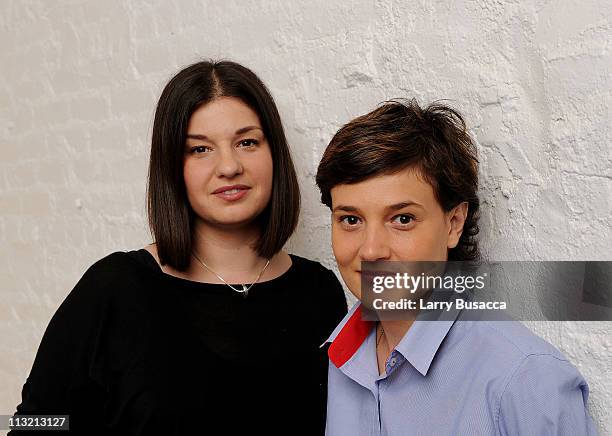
9;255;124;435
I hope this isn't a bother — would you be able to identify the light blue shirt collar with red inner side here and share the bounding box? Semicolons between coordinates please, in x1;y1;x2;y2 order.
321;294;460;376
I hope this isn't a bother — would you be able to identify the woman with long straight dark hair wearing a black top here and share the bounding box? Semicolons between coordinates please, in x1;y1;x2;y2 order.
17;61;346;435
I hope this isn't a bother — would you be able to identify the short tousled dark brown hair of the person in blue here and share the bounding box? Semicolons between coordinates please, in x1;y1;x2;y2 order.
317;100;480;260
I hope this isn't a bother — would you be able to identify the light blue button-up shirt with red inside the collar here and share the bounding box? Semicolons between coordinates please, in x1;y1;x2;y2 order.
326;303;597;436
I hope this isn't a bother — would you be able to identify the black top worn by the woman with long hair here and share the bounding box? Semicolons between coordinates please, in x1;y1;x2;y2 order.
11;249;347;435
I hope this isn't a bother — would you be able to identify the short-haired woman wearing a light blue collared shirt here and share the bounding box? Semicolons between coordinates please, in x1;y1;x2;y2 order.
317;101;596;436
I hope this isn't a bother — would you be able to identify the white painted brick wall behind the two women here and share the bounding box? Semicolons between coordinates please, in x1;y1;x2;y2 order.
0;0;612;434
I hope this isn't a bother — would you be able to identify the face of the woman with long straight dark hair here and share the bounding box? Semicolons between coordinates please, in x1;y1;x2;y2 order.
183;97;273;232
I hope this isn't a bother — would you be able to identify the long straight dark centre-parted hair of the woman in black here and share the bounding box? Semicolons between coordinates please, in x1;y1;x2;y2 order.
147;61;300;271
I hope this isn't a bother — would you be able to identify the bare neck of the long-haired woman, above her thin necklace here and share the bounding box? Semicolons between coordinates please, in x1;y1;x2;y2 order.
193;223;262;275
